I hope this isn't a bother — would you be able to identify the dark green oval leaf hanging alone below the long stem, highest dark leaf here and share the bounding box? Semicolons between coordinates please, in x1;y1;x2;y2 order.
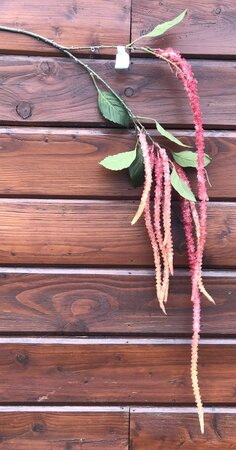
98;89;130;127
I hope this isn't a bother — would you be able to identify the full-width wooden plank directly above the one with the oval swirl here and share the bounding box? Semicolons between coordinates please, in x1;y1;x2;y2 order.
0;199;236;268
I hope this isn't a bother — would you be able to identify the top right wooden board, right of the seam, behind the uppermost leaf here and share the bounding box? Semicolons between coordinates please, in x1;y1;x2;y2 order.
132;0;236;56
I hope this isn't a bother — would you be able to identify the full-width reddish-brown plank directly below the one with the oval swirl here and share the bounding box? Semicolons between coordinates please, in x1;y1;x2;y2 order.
0;338;236;405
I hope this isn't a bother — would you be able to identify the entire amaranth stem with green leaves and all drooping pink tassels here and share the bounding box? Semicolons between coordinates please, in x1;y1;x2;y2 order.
0;18;213;433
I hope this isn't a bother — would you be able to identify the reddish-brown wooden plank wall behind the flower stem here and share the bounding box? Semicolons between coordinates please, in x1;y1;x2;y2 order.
0;0;236;450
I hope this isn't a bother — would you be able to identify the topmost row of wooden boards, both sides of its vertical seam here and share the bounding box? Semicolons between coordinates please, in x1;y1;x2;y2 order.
0;0;236;56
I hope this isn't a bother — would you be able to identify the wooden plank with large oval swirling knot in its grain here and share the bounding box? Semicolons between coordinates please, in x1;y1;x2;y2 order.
0;269;236;336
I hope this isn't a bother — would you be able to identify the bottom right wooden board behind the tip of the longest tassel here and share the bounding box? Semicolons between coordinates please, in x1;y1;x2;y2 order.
131;408;236;450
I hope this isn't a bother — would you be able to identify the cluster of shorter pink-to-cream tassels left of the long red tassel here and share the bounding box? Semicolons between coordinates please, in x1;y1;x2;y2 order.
131;131;173;313
